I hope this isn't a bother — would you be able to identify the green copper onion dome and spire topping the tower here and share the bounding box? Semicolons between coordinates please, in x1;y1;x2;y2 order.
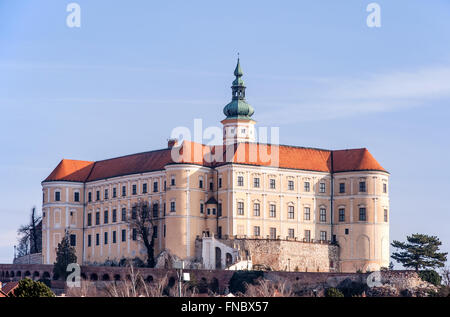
223;59;255;120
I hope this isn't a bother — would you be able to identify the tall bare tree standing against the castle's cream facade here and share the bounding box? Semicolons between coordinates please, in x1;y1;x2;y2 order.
126;201;159;267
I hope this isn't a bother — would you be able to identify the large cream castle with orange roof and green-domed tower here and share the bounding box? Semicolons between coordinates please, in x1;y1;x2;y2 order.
42;60;389;272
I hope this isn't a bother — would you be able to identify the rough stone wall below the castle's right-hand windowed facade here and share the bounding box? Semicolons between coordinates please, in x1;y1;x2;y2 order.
220;239;339;272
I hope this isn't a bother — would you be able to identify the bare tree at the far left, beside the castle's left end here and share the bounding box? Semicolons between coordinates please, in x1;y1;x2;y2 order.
17;207;42;256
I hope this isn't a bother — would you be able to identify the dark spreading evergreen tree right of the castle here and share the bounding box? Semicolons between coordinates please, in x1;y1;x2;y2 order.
391;233;447;271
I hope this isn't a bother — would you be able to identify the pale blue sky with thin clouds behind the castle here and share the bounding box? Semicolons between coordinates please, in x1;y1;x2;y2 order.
0;0;450;263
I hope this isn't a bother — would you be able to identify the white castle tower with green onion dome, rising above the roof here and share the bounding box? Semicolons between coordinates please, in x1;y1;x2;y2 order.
222;58;256;145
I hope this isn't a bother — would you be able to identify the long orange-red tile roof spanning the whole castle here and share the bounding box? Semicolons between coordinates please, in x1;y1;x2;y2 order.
44;141;386;182
